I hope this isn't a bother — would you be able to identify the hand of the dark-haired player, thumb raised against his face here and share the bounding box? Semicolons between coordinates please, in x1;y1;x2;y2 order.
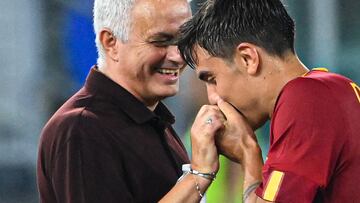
216;99;261;164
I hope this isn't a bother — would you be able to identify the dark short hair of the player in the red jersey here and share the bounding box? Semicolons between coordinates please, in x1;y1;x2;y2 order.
178;0;295;68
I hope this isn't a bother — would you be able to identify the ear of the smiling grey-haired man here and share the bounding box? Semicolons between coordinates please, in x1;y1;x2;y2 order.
99;29;119;61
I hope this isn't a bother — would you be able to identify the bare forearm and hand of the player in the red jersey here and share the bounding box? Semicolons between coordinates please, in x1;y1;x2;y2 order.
216;100;272;203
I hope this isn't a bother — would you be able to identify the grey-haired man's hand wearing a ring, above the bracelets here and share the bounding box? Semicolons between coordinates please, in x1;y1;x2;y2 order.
191;105;225;173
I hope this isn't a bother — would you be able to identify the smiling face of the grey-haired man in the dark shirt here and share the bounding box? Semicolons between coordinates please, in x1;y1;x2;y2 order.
116;0;191;106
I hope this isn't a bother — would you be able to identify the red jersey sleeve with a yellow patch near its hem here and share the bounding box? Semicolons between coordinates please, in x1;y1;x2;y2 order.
256;78;344;202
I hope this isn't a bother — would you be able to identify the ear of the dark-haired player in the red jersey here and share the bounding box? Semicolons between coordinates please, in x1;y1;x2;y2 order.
234;42;260;75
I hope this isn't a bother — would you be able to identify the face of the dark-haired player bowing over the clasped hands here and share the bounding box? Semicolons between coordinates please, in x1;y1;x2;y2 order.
195;48;267;129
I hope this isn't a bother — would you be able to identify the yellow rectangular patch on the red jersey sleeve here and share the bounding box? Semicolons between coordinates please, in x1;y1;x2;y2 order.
264;171;285;202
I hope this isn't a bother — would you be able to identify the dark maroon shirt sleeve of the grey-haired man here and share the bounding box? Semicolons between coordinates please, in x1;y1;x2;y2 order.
52;116;134;203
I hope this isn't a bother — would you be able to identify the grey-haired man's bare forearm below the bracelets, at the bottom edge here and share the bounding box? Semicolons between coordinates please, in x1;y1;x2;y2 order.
159;173;212;203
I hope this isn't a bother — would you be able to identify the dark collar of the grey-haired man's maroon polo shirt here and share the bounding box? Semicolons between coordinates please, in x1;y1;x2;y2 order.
85;66;175;124
